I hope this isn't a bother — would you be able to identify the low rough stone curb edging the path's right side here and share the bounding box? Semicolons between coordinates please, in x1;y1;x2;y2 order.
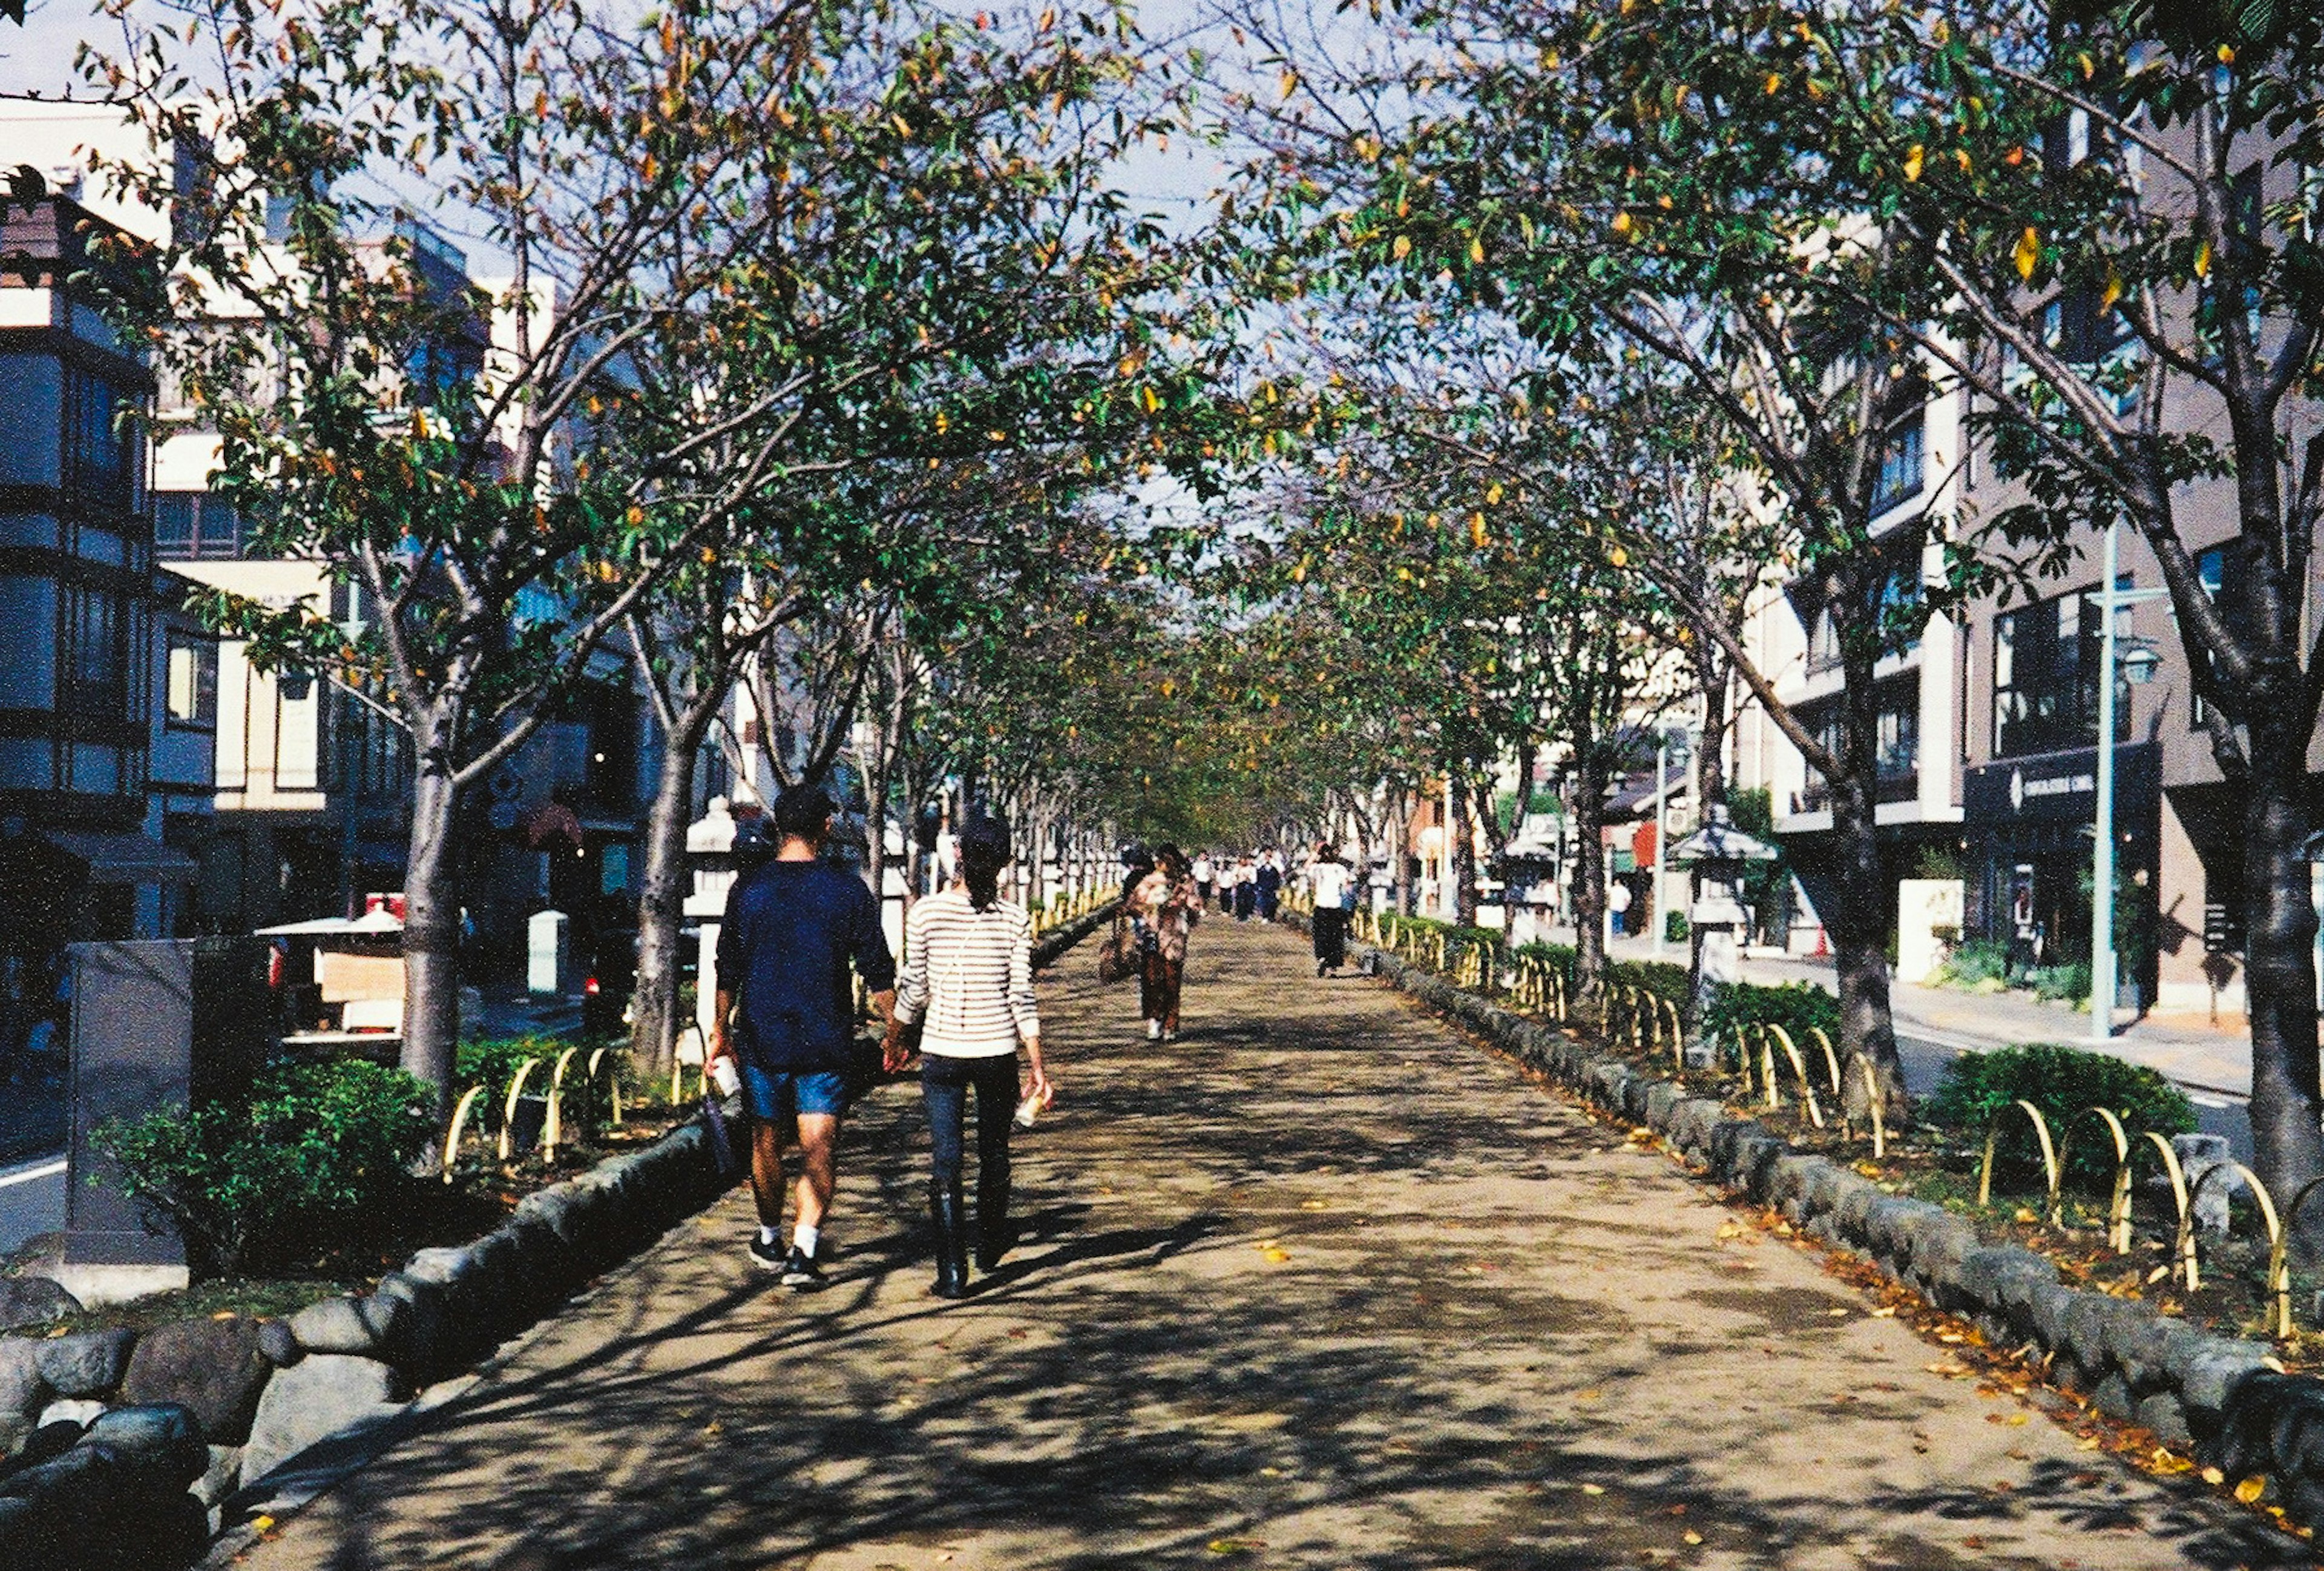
1350;924;2324;1527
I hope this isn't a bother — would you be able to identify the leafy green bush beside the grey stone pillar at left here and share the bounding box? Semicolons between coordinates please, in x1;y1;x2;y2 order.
95;1059;435;1276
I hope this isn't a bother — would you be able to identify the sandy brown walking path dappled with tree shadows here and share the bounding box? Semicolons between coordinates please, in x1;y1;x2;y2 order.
226;923;2308;1571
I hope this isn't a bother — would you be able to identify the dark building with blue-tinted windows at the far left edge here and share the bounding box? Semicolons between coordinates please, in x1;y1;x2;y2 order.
0;195;209;943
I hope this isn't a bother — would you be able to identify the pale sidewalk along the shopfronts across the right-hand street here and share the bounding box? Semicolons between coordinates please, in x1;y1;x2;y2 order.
1606;937;2252;1097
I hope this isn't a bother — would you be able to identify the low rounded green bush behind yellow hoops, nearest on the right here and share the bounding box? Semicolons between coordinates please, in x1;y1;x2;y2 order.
1925;1041;2194;1183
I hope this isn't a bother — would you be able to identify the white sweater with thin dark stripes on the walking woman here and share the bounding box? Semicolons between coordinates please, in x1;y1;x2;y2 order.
894;890;1041;1058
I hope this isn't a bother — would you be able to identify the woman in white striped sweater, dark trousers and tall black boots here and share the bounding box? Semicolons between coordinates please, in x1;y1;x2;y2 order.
881;818;1055;1299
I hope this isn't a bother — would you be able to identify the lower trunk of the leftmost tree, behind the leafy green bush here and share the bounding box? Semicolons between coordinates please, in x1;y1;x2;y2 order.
402;730;460;1122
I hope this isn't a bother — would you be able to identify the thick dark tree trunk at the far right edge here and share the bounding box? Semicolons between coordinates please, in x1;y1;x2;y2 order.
2231;743;2324;1260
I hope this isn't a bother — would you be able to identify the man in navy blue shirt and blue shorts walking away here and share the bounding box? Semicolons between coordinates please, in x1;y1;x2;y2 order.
711;786;894;1292
